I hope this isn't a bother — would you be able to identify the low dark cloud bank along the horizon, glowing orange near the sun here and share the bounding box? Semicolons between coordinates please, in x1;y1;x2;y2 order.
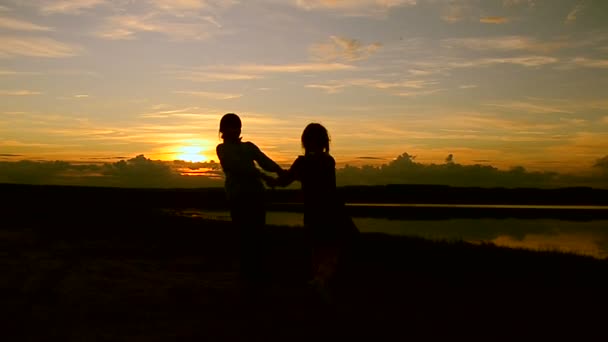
0;153;608;188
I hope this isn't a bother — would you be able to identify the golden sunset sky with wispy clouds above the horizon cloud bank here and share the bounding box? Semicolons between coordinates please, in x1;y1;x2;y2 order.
0;0;608;172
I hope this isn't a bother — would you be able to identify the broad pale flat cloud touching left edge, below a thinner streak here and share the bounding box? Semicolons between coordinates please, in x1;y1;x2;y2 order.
0;36;82;58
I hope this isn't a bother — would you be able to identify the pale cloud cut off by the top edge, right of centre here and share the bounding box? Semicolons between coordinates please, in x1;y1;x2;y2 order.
295;0;417;16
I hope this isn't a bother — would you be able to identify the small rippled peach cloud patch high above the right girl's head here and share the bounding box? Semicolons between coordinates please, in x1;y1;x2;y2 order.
310;36;381;62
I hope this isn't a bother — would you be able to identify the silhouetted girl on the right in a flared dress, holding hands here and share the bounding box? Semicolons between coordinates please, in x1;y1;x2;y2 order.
269;123;358;287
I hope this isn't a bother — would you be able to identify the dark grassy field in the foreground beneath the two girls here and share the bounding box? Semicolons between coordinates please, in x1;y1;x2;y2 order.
0;204;608;341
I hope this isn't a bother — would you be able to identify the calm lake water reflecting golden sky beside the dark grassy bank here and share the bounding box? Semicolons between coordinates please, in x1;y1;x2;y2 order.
175;208;608;258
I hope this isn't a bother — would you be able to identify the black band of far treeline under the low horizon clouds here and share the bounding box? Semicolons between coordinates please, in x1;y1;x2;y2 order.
0;184;608;208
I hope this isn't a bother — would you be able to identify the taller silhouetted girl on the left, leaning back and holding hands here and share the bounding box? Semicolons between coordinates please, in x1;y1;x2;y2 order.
216;113;283;282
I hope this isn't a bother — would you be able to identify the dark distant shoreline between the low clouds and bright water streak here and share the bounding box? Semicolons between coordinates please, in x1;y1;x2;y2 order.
0;183;608;206
